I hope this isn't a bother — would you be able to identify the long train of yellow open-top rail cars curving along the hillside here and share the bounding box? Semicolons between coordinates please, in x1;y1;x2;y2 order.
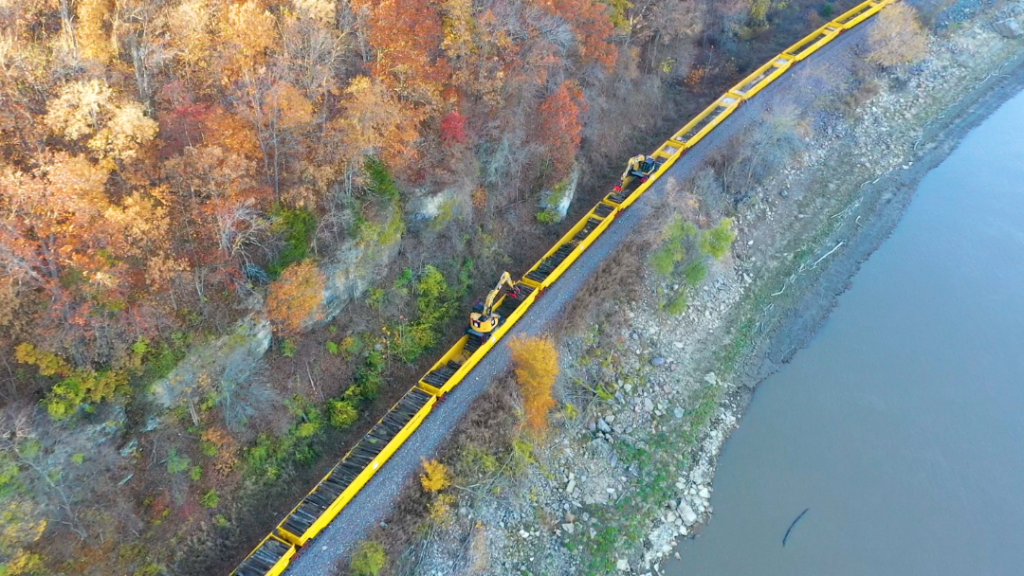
230;0;897;576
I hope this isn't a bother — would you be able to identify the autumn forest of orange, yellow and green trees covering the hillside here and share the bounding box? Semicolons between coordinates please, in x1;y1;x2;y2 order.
0;0;831;576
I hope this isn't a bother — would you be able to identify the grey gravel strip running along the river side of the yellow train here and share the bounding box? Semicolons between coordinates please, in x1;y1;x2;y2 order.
285;23;870;576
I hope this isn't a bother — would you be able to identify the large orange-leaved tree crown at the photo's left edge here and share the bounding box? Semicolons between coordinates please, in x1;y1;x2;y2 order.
0;153;176;363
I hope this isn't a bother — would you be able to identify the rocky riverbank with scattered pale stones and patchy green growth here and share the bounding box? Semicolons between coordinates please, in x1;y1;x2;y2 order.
366;2;1024;574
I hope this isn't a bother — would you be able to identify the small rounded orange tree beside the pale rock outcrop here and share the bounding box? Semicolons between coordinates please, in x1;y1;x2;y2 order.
266;260;327;334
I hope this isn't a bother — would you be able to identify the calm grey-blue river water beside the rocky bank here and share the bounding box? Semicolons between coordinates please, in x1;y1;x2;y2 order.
665;89;1024;576
